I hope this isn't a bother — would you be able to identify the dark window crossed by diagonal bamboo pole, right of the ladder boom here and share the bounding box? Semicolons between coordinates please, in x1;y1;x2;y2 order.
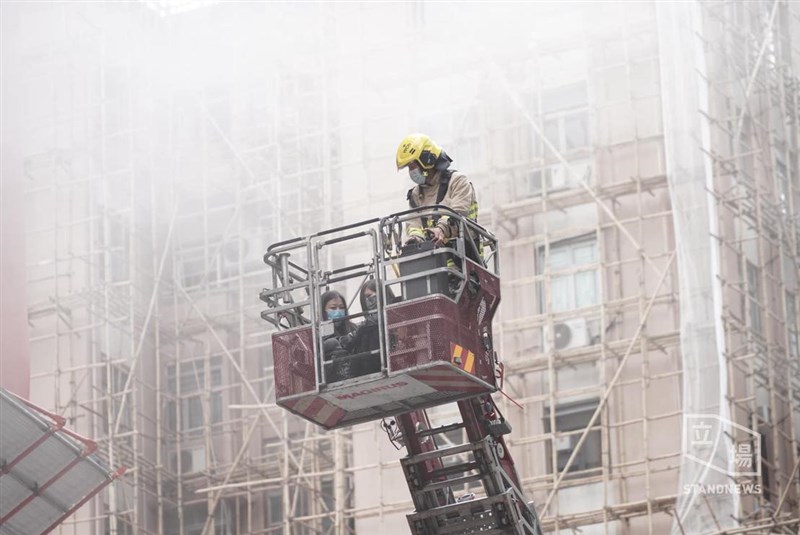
544;399;602;475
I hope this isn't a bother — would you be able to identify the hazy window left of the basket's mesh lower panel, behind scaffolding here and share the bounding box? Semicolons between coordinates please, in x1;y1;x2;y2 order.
167;357;222;431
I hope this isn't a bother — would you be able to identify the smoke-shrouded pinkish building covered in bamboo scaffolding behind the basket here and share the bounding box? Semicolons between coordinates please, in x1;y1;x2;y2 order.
2;1;800;534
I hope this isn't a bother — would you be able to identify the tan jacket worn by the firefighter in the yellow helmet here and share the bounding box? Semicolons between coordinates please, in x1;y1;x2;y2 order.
406;171;478;240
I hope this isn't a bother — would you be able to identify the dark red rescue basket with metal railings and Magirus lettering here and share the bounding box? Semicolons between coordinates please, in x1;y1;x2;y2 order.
261;207;500;429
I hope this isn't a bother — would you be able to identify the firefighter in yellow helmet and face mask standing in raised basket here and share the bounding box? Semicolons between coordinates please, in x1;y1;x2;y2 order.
396;134;478;262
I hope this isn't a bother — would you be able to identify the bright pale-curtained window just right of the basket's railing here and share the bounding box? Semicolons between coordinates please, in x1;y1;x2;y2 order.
536;235;600;313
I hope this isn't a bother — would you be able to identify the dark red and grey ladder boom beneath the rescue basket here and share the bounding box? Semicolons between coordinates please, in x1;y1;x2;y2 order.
397;395;541;535
